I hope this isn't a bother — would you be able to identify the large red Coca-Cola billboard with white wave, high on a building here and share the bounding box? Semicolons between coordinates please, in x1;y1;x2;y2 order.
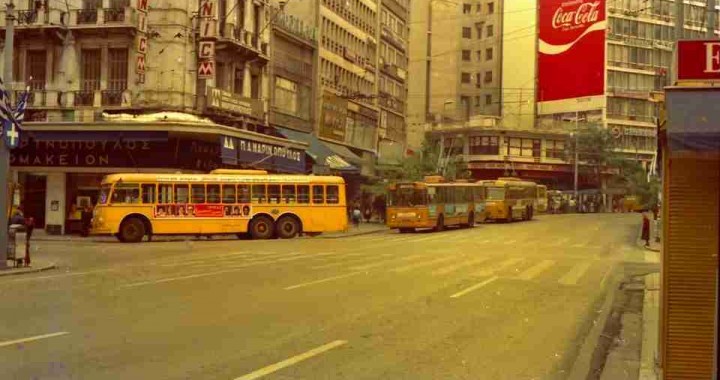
537;0;607;102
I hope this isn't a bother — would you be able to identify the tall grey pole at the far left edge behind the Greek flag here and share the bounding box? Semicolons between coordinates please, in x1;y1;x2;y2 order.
0;0;15;269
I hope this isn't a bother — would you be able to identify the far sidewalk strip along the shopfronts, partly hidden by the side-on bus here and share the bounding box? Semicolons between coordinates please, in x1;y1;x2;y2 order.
32;222;389;243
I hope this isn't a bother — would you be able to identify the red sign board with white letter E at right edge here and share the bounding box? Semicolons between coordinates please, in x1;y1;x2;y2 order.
677;40;720;81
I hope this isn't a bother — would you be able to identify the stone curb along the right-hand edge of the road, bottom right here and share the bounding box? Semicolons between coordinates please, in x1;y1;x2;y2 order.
567;263;618;380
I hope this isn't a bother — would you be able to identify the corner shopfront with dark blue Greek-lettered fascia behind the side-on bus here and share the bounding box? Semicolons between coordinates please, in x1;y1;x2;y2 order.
10;124;309;234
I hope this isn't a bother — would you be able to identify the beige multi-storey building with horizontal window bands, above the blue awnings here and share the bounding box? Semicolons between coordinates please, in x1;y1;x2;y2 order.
285;0;380;180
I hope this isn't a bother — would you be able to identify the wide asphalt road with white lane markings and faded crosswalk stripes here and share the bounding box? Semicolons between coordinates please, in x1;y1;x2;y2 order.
0;214;639;380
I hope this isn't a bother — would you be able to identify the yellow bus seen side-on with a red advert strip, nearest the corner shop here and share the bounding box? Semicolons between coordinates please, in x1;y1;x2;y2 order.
92;169;347;242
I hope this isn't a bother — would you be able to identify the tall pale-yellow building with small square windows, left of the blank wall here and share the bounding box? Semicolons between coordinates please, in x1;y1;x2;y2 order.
408;0;504;148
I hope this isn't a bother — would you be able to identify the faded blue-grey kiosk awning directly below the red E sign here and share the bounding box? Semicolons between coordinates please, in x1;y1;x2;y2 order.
666;88;720;152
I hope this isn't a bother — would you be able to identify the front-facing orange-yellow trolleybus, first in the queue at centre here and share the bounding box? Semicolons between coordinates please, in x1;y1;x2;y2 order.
386;176;485;233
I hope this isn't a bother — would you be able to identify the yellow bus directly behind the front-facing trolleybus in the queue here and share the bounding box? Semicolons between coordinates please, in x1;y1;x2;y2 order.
479;177;538;222
